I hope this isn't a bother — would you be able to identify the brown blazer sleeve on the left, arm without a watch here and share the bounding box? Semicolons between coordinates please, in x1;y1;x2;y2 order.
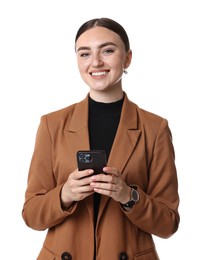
22;116;75;230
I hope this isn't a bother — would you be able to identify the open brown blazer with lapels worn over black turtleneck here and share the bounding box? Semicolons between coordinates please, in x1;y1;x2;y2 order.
22;94;179;260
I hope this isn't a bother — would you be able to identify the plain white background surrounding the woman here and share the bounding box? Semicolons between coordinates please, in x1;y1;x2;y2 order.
0;0;207;260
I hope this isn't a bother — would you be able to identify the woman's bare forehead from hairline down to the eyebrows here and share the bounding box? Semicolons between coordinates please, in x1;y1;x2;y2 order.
76;26;124;49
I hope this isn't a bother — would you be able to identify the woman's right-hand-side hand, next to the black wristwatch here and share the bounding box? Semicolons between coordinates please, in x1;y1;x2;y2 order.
90;166;131;204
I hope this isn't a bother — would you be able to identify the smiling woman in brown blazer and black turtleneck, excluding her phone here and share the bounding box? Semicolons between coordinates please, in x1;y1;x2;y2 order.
22;18;179;260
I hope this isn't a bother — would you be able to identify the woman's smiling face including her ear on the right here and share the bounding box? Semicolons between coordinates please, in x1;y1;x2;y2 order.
76;26;131;96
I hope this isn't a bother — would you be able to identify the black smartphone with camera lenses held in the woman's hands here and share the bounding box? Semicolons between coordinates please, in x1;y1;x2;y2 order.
77;150;106;174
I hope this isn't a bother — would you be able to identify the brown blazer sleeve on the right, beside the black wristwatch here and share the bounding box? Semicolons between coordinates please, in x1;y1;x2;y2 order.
125;119;180;238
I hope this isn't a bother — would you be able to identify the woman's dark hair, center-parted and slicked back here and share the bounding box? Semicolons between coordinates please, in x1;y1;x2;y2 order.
75;18;130;51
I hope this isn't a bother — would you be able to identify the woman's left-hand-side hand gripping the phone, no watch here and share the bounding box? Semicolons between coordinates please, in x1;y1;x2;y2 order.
61;169;94;208
